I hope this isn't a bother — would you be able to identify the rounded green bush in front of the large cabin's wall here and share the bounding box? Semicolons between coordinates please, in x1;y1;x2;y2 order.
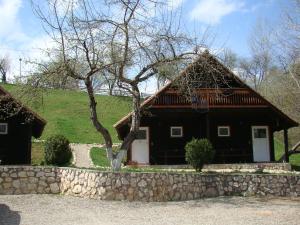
185;138;215;171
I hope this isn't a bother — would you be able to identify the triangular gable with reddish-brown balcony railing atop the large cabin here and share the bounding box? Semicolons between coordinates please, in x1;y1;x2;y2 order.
114;51;298;129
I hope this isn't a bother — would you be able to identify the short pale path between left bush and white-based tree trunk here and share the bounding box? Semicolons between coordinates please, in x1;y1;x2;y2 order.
71;144;103;168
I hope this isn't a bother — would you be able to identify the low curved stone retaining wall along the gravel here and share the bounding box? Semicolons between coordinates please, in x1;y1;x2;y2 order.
0;167;300;201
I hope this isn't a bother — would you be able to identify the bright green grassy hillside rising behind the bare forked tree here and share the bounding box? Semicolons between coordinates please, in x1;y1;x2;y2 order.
3;85;131;143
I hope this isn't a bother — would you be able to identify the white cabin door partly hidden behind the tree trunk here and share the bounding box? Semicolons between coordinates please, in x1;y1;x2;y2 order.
131;127;149;164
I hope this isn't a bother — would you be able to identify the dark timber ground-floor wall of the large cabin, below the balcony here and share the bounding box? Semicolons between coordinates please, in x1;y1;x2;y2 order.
134;109;275;165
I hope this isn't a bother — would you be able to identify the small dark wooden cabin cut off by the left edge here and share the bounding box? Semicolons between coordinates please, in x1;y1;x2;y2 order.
0;86;46;165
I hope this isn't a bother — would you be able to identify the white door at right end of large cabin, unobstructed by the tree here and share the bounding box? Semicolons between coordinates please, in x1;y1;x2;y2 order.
252;126;270;162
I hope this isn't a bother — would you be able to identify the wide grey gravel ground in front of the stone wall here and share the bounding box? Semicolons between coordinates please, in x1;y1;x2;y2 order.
0;195;300;225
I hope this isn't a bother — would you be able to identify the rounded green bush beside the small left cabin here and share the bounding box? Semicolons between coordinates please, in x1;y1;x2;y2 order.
45;135;72;166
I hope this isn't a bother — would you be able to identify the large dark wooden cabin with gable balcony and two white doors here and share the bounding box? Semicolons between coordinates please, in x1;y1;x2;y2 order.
114;52;298;165
